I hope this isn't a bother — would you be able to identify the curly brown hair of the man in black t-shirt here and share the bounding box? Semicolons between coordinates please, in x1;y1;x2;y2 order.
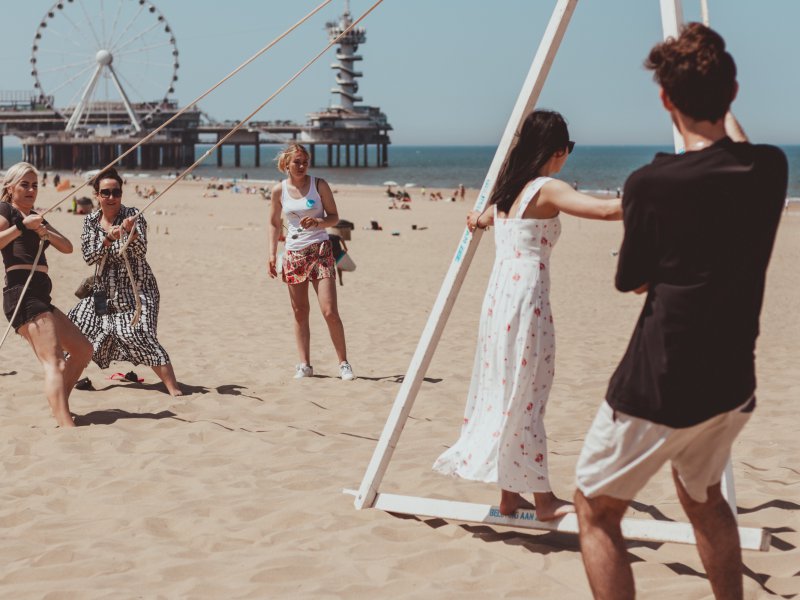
644;23;736;122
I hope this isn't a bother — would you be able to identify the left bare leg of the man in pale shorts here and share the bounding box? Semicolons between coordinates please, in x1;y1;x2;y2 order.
575;490;635;600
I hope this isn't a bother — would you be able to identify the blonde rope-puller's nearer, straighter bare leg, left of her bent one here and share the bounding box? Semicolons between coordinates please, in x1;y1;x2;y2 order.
19;312;83;427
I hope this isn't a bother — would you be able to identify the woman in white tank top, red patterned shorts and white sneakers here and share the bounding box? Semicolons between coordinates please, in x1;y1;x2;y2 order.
268;144;354;380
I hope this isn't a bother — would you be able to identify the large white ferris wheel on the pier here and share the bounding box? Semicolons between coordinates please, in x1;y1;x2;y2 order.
31;0;178;132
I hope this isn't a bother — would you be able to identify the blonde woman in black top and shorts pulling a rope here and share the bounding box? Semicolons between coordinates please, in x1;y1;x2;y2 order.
0;162;92;427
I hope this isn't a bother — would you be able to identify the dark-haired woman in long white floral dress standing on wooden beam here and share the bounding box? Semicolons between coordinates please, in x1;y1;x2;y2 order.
434;110;622;521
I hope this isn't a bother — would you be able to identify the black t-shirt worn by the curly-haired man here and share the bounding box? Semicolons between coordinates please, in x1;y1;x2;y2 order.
606;138;788;428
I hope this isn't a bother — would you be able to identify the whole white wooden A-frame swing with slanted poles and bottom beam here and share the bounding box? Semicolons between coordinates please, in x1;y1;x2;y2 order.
345;0;769;551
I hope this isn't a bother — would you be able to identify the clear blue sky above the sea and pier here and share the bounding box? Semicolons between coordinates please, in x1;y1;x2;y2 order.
0;0;800;145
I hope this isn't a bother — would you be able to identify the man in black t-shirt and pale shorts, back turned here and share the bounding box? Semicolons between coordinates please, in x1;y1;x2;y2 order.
575;23;788;598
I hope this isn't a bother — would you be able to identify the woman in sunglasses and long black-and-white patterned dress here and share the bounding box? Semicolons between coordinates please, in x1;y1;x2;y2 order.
69;168;183;396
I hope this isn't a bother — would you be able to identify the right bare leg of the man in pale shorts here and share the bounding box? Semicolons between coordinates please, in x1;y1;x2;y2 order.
672;469;744;600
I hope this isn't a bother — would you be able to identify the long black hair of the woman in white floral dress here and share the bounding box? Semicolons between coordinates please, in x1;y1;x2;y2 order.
489;110;569;213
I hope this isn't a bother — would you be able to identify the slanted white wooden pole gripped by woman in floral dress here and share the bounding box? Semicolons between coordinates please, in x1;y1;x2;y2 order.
354;0;578;509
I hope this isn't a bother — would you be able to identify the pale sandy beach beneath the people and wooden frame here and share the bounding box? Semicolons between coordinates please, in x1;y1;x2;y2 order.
0;179;800;600
